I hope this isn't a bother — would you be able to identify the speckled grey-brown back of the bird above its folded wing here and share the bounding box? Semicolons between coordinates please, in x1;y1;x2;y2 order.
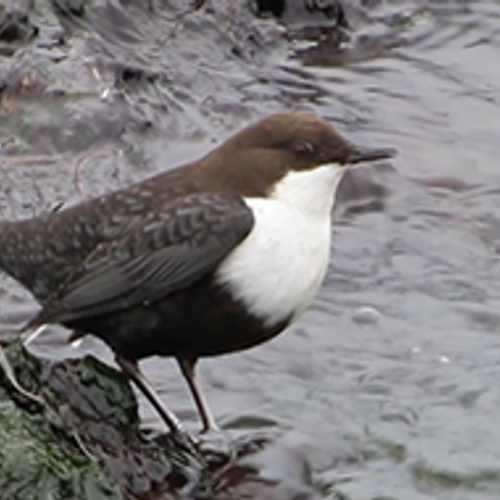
0;166;197;304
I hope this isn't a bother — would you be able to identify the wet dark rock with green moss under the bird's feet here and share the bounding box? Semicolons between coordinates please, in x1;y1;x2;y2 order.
0;342;324;500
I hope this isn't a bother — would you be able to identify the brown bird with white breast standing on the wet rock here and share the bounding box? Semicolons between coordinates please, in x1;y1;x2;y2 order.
0;112;394;431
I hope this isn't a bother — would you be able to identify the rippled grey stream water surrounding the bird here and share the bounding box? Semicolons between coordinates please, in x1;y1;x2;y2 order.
2;0;500;500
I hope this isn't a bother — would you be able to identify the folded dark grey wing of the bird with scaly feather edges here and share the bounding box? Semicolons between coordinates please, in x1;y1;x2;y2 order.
30;194;253;324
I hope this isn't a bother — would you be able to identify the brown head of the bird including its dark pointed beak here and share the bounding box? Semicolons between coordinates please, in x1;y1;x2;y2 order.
195;112;395;196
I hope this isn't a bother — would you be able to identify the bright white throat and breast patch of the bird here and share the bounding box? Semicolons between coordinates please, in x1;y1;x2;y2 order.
216;164;344;327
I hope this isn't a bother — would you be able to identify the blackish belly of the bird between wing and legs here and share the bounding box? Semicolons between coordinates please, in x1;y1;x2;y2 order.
67;278;288;360
